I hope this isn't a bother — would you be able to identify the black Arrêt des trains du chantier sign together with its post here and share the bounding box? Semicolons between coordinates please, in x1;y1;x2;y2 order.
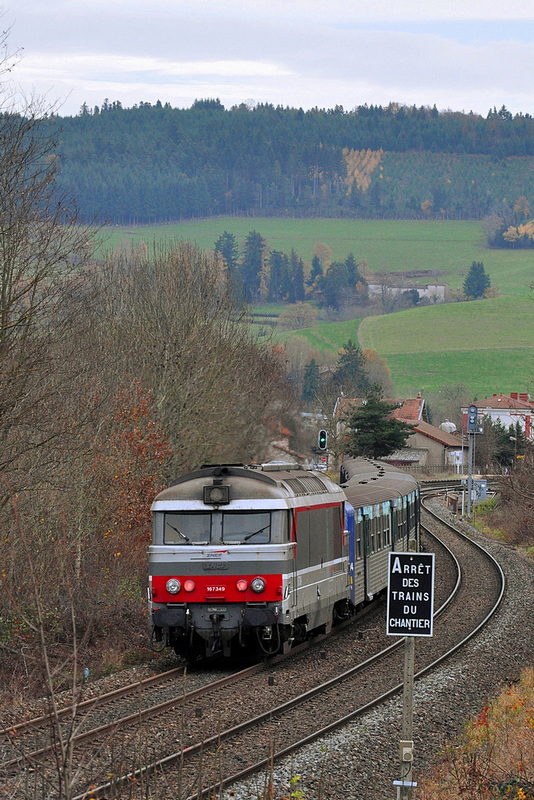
386;552;434;800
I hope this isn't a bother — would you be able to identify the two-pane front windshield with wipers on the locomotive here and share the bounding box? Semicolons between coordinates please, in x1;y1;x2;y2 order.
164;511;276;544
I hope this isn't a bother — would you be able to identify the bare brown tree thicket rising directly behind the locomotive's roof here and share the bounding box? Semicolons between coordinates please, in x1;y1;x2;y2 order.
88;242;298;473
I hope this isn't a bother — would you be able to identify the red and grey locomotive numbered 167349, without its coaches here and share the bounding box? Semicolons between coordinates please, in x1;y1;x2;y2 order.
149;464;349;658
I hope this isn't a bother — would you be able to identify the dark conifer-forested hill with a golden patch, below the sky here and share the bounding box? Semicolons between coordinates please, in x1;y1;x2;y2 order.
52;100;534;224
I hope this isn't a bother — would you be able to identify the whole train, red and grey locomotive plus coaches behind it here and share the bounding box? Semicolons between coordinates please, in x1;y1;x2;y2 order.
148;458;420;663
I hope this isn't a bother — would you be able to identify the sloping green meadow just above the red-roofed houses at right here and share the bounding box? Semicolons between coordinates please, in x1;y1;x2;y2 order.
358;296;534;397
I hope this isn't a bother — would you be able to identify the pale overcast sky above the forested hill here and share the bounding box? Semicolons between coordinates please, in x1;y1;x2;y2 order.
2;0;534;116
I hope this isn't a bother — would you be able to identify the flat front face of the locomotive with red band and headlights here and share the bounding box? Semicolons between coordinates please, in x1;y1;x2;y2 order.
149;466;292;660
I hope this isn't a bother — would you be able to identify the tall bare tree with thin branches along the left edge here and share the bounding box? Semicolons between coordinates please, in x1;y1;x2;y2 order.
0;100;92;485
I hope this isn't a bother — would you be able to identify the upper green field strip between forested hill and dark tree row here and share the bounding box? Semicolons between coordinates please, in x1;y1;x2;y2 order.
102;217;534;294
